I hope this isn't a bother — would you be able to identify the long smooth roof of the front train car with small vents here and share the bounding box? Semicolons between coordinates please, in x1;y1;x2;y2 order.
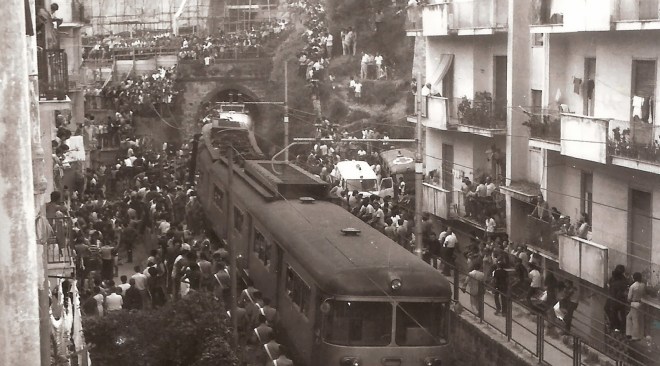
206;150;451;298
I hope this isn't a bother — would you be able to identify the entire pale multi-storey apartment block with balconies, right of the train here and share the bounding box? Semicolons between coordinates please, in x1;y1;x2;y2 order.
408;0;660;348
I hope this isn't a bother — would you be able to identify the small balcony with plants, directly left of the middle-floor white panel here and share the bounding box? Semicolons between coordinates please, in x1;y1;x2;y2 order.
523;109;561;151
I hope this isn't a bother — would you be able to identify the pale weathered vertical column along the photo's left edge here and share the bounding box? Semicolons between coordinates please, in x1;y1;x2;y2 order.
0;0;41;365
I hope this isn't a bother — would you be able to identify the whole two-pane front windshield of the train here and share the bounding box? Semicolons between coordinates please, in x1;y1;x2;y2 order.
323;300;448;347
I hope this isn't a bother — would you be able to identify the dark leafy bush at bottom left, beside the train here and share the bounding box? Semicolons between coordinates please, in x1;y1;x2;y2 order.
83;292;238;366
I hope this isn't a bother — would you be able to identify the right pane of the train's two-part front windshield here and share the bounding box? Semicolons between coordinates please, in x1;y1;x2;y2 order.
396;302;448;346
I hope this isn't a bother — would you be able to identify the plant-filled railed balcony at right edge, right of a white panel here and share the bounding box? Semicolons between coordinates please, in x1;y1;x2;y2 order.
607;120;660;174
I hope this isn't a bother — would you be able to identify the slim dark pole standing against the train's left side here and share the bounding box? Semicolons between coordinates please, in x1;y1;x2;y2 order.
225;145;239;347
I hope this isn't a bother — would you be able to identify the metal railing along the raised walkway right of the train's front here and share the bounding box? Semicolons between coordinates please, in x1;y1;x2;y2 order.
440;260;652;366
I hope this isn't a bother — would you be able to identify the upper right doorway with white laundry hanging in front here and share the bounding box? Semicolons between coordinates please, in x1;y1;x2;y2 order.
630;60;656;123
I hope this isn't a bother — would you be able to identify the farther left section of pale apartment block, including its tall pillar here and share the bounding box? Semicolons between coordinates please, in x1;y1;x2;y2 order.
408;0;529;237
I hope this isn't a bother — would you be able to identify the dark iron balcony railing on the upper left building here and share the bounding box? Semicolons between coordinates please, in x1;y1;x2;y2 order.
37;49;69;100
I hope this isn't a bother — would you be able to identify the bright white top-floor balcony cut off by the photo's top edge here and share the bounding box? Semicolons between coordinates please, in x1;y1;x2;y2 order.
531;0;612;33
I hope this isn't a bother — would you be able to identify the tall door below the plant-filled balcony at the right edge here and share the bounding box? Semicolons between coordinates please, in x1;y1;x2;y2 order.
628;189;653;272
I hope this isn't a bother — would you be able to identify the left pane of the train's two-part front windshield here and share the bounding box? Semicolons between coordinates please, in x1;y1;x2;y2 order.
323;301;392;346
